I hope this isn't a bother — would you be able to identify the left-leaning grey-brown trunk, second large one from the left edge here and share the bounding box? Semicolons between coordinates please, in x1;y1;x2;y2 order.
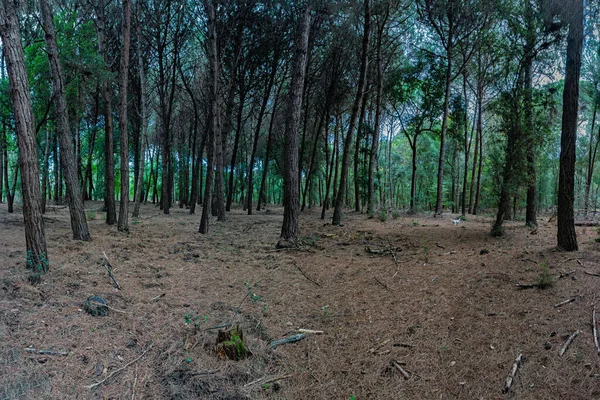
40;0;90;241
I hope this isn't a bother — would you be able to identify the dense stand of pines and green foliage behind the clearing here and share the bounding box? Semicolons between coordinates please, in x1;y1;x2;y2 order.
0;0;600;276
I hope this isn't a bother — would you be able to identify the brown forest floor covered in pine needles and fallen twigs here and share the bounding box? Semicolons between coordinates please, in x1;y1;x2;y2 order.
0;202;600;399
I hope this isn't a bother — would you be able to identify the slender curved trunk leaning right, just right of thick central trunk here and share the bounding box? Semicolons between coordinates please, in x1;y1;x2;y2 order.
332;0;371;225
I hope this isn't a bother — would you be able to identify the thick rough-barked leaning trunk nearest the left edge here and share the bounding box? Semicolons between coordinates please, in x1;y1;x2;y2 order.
0;0;49;276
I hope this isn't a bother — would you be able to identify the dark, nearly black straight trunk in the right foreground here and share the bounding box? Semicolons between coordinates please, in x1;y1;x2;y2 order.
557;0;583;251
